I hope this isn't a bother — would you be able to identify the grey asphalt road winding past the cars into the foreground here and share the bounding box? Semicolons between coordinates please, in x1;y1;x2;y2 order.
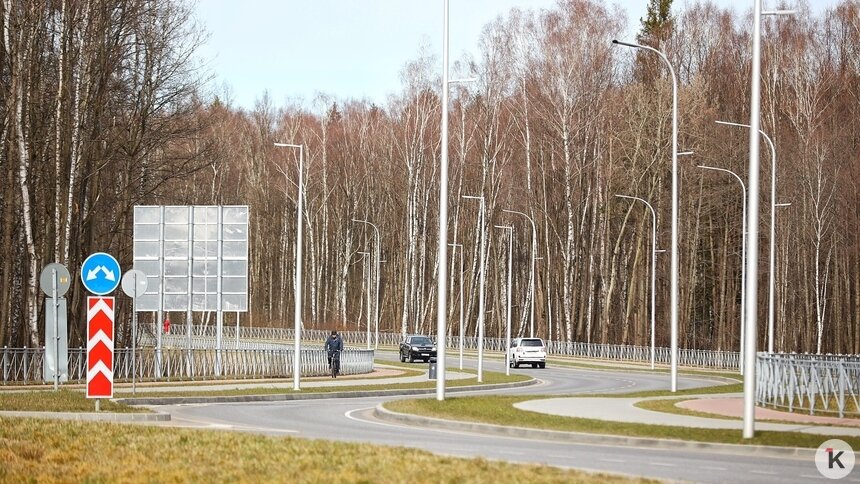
155;353;860;483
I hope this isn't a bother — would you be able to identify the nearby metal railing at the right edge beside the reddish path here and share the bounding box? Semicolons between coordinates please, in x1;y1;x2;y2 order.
756;353;860;418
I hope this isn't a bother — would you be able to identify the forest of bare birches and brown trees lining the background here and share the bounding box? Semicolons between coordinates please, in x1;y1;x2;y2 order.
0;0;860;353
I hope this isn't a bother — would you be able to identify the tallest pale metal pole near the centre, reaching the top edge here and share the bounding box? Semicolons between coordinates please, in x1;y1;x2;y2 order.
436;0;448;401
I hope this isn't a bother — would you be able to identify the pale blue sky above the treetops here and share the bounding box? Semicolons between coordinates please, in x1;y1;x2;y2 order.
196;0;837;109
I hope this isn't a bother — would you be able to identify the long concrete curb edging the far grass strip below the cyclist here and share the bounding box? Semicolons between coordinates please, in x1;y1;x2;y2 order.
114;378;540;406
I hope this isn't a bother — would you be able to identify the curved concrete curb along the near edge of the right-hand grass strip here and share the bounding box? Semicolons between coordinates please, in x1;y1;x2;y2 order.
373;404;816;461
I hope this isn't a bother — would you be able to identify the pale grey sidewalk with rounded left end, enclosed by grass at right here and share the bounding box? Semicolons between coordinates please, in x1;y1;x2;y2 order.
514;394;860;437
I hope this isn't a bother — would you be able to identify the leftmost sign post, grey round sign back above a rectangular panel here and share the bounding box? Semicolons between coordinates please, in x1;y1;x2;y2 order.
39;262;71;390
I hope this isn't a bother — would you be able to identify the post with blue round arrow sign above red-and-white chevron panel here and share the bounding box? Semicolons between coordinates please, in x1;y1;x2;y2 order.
81;252;121;412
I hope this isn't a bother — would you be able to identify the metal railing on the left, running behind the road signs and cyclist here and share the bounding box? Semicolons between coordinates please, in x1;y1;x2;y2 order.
0;347;374;384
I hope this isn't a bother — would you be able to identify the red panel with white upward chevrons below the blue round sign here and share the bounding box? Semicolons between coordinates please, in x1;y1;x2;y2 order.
87;296;114;398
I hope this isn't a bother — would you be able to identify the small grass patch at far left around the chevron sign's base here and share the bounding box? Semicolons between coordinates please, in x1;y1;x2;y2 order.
0;390;150;412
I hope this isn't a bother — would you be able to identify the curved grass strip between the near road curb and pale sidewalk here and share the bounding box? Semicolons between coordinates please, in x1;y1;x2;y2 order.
385;394;860;448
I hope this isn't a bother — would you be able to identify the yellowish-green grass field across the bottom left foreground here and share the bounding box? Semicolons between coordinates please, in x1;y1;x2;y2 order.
0;418;646;483
